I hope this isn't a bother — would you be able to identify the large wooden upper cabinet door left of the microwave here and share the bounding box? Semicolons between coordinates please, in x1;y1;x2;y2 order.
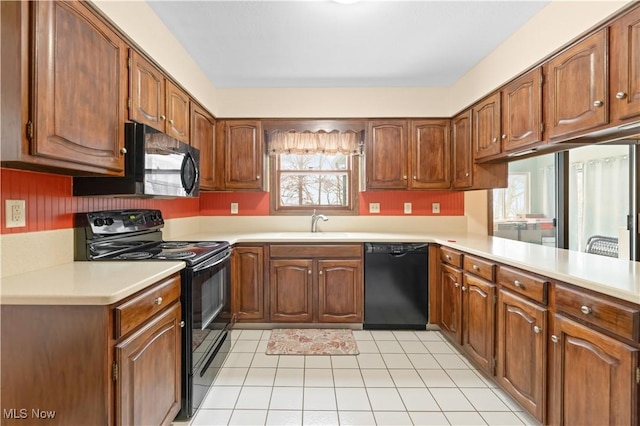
31;1;127;174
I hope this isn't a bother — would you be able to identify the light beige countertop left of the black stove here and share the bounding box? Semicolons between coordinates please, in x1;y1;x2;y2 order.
0;261;185;305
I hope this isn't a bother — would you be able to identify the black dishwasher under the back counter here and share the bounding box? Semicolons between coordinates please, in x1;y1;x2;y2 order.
363;243;429;330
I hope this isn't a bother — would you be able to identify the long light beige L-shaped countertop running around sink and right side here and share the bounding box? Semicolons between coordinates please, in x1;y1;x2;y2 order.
181;232;640;304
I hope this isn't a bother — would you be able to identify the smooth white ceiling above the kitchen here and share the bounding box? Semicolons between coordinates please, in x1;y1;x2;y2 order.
148;0;549;88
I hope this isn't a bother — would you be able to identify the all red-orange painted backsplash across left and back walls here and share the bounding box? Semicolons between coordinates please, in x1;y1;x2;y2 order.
0;168;464;234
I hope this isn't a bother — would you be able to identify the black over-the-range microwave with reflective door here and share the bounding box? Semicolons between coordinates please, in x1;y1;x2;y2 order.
73;123;200;198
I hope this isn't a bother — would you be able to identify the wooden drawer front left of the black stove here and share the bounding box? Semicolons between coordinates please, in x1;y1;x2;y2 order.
115;274;180;339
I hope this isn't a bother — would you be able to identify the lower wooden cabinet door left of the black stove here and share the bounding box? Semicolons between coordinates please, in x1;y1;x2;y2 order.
115;303;181;426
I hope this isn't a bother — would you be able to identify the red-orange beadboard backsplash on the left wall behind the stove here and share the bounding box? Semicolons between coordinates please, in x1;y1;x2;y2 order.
0;168;200;234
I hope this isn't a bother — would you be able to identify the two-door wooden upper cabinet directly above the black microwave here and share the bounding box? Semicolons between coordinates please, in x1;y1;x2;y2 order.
129;49;190;143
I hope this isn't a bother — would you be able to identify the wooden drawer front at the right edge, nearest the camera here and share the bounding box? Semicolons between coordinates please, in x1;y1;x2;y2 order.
555;285;640;341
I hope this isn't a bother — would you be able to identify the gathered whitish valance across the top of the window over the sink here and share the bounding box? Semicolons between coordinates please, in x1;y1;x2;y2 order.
269;130;360;155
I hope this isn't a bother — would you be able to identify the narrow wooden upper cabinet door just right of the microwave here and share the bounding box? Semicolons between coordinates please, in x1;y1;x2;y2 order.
189;102;220;190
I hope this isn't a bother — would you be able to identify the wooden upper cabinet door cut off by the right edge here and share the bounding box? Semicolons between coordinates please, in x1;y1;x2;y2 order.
609;8;640;120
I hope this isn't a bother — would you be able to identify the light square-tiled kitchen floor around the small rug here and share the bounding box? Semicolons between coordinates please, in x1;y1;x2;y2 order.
181;330;538;426
